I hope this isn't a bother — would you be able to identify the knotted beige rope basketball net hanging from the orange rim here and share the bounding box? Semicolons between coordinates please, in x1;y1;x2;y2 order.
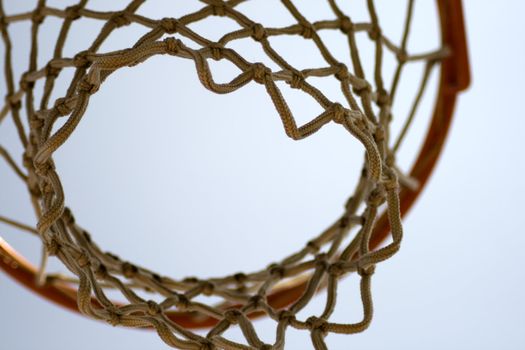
0;0;465;349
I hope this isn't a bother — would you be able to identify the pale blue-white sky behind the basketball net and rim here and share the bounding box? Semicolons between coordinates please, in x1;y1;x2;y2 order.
0;0;525;350
